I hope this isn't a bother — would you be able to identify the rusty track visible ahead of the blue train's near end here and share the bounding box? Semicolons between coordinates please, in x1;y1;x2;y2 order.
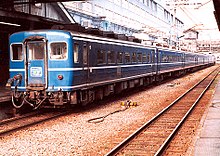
0;111;69;137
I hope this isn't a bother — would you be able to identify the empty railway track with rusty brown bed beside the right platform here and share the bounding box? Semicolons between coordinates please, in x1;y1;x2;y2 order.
106;69;219;156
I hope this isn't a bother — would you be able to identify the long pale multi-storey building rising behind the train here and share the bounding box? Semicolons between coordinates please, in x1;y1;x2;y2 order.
63;0;184;46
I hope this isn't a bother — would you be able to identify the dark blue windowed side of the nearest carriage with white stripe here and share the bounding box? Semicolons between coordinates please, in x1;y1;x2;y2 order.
73;37;156;87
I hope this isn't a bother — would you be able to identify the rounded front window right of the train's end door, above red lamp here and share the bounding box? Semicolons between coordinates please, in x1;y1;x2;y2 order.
50;42;67;59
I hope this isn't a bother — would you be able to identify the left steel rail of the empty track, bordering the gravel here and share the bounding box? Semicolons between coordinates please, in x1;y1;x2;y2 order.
105;68;217;156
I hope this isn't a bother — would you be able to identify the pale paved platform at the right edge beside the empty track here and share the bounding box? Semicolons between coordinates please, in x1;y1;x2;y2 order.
194;78;220;156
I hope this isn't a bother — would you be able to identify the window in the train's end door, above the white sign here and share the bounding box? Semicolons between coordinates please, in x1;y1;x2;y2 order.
27;41;45;60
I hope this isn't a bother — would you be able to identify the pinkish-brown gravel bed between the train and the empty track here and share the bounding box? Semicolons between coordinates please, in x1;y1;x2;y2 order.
0;67;215;156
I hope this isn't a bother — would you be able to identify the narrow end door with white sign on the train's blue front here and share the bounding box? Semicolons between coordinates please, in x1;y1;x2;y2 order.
25;39;47;90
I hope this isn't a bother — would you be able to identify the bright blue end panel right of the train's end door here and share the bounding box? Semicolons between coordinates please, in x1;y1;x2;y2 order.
47;33;74;91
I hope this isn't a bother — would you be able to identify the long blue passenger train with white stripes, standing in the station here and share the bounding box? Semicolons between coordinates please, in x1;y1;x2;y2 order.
7;29;215;109
